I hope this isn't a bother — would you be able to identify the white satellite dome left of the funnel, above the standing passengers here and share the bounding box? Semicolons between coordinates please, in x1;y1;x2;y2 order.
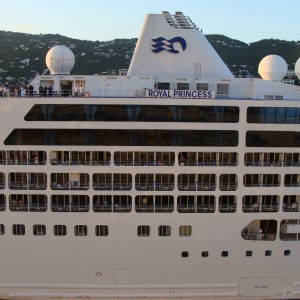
46;46;75;75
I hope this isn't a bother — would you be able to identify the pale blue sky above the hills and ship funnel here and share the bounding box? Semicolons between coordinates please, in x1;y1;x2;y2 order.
0;0;300;43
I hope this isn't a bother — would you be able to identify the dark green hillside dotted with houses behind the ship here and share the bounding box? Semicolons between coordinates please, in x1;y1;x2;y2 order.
0;31;300;85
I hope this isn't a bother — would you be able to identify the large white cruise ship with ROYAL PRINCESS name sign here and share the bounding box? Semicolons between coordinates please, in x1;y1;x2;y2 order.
0;11;300;300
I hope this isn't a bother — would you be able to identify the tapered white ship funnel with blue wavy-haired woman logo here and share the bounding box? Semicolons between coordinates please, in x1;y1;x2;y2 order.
127;11;233;78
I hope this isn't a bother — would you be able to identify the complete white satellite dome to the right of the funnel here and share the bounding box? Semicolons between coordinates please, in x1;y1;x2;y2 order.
258;54;287;81
